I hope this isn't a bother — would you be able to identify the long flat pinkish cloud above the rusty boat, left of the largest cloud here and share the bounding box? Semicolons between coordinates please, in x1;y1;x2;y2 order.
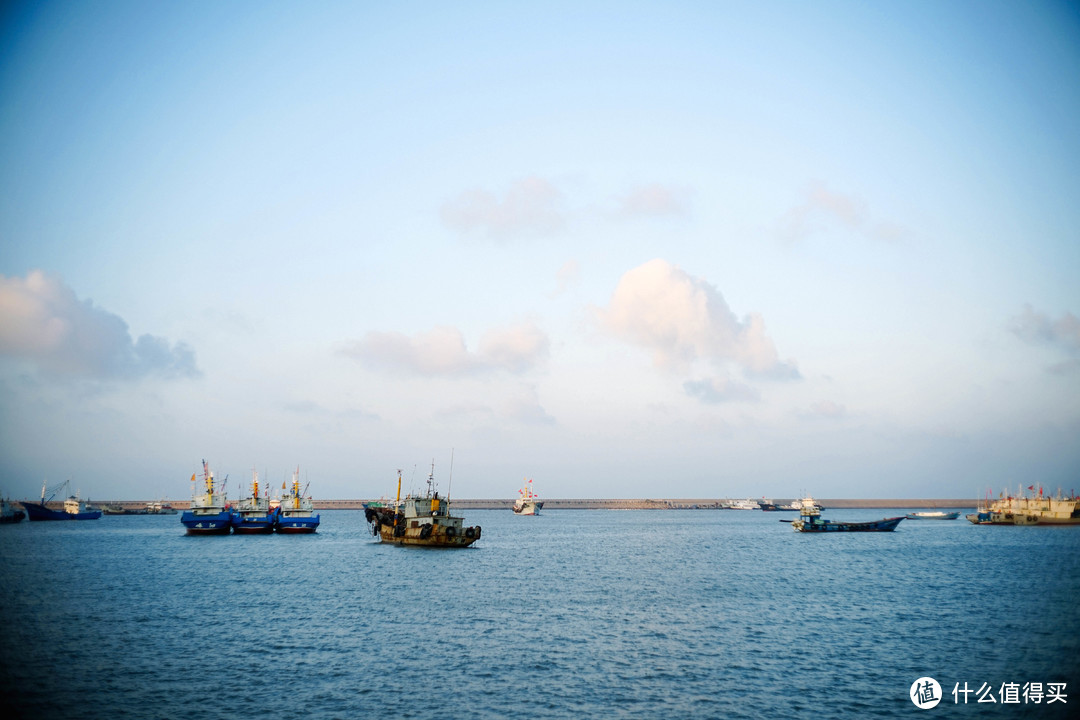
342;322;550;377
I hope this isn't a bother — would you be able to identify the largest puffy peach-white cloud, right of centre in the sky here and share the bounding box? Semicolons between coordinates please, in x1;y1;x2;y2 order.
597;259;799;382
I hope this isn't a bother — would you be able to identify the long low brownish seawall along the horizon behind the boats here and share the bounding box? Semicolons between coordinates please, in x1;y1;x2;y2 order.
90;498;976;511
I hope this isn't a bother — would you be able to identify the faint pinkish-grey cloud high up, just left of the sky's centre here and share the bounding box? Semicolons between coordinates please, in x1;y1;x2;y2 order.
441;177;566;239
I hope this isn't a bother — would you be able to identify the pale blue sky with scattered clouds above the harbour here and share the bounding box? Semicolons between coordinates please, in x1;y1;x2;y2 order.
0;0;1080;500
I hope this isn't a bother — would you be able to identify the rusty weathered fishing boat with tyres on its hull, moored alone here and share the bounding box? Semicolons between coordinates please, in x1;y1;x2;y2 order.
364;462;481;547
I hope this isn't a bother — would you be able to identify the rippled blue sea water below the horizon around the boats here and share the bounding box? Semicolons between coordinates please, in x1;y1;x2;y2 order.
0;510;1080;720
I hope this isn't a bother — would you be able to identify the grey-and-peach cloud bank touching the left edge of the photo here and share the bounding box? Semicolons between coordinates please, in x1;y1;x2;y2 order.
0;270;200;379
